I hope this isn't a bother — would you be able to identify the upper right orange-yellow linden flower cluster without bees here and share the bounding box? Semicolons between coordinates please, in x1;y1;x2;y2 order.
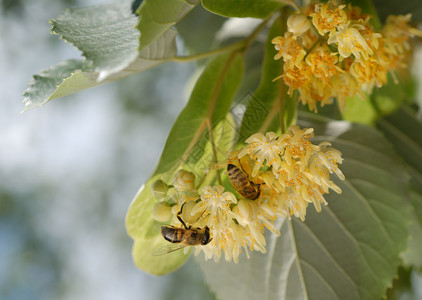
272;1;422;111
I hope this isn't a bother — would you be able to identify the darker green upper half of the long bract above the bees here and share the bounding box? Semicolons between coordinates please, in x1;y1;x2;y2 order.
155;52;244;174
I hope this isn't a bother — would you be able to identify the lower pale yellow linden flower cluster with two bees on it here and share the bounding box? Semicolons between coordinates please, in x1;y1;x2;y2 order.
153;126;344;263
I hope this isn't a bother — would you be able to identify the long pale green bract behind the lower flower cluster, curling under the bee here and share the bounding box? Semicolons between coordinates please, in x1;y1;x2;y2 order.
126;54;244;275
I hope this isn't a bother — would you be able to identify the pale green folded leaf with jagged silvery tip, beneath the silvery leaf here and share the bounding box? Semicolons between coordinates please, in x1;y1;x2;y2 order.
23;30;177;111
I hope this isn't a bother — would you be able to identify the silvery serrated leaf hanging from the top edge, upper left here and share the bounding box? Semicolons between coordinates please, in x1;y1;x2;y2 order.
51;0;139;81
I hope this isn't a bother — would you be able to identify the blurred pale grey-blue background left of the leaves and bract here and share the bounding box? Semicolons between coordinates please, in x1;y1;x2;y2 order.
0;0;214;300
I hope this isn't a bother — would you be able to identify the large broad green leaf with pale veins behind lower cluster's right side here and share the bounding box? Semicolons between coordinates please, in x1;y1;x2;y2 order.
200;115;409;300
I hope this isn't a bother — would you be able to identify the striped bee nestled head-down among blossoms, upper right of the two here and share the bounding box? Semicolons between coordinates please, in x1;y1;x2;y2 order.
227;164;261;200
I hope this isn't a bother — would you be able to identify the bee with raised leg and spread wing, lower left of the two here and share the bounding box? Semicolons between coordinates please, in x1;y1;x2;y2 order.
152;202;212;256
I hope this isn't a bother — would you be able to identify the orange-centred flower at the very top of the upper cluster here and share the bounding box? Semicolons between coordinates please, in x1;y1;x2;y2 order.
310;1;347;36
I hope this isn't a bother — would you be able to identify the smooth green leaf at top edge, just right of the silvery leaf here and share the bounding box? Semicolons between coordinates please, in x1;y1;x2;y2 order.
136;0;199;50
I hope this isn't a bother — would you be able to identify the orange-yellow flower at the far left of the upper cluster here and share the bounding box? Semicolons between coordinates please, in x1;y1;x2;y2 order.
271;32;306;66
